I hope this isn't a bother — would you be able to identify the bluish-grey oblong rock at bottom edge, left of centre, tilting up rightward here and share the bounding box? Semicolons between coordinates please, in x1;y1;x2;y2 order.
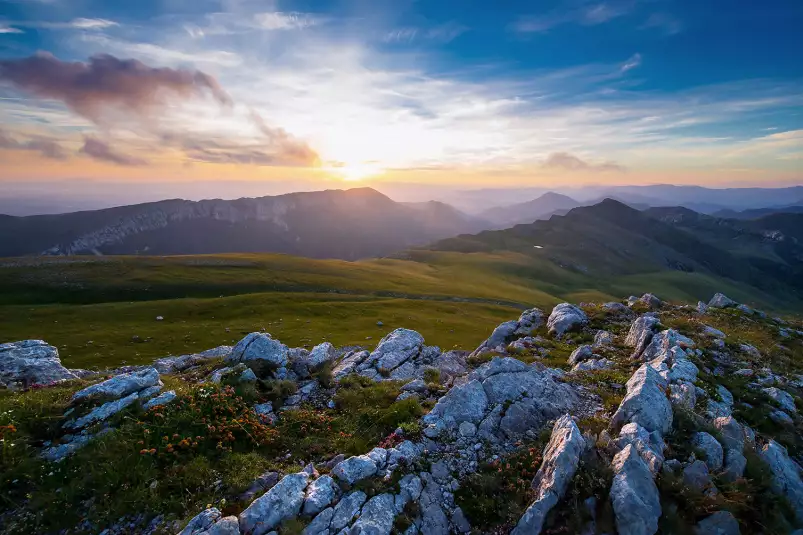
239;472;309;535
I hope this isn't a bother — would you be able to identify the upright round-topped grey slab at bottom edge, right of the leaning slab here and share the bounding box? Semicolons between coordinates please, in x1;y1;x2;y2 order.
610;445;661;535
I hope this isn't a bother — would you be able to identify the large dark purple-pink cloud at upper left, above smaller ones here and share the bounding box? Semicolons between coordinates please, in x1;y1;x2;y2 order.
0;52;231;123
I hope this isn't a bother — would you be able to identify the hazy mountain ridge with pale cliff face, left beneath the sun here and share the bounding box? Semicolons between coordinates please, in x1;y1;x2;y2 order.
0;188;484;260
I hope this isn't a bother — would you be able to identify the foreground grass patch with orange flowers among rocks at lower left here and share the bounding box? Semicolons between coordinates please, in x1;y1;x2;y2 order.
0;378;423;534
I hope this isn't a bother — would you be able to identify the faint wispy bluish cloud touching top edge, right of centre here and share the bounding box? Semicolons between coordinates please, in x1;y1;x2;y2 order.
510;0;636;33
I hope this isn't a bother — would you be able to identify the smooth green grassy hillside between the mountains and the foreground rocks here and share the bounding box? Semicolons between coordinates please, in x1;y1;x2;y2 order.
0;247;794;367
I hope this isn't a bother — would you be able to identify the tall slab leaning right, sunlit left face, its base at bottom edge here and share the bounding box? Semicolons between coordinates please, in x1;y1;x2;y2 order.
511;414;586;535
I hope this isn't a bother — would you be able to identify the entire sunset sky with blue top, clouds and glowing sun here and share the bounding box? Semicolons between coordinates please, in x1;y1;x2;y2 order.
0;0;803;196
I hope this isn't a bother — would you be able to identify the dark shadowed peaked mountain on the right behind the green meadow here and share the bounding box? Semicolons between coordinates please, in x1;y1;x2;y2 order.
418;199;803;300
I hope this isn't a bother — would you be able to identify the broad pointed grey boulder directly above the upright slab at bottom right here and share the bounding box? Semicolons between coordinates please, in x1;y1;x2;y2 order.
611;364;672;434
